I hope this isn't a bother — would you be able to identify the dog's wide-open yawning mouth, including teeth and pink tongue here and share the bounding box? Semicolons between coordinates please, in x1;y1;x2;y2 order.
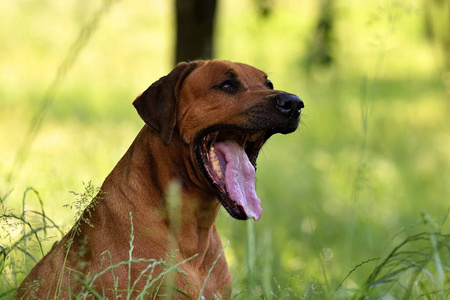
197;129;270;221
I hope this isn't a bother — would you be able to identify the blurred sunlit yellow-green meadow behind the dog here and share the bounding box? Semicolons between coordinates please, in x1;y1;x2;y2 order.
0;0;450;298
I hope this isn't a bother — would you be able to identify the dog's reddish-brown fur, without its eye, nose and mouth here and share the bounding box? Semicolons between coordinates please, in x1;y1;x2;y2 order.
17;61;302;299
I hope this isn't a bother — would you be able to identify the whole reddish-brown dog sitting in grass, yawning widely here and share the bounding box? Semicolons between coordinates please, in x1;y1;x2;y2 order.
17;61;303;299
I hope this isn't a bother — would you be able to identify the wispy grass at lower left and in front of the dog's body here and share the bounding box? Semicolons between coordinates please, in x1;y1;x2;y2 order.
0;182;204;299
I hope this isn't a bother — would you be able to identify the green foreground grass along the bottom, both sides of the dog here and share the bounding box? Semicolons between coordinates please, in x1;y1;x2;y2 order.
0;192;450;299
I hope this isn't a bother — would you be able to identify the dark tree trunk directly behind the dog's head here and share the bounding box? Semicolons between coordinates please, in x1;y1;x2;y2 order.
175;0;217;63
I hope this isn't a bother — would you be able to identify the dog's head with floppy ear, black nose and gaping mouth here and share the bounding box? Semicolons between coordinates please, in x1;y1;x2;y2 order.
133;61;304;220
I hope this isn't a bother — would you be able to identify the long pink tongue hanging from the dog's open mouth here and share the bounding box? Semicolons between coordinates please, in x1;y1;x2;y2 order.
214;141;262;221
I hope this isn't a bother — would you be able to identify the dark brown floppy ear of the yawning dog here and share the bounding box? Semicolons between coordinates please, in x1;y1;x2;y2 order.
133;62;198;146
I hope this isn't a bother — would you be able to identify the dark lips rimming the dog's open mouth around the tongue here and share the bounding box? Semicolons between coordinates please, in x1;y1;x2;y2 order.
195;126;271;220
